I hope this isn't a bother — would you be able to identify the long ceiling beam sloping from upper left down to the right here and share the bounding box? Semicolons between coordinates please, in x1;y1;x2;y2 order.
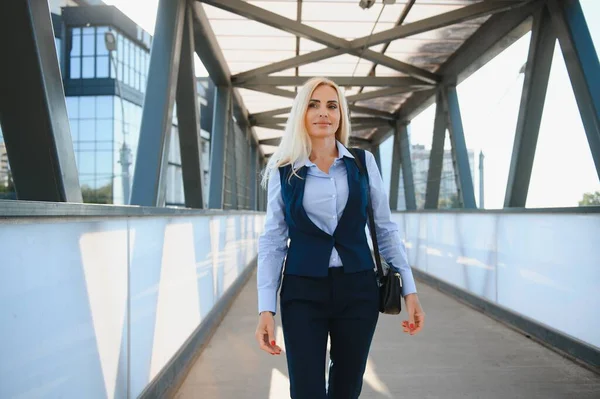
201;0;439;83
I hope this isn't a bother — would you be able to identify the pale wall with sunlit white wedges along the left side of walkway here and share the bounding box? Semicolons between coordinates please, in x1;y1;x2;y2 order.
0;213;264;399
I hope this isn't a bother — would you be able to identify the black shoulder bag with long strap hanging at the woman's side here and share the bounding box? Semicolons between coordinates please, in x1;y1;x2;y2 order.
348;149;402;314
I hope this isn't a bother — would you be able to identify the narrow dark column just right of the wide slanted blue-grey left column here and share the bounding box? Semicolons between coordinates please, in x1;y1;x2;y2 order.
177;5;205;209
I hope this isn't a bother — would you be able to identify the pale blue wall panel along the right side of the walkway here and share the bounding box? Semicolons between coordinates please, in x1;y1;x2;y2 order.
393;212;600;348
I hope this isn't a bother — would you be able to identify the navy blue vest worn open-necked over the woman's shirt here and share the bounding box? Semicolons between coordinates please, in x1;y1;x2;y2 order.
279;149;375;277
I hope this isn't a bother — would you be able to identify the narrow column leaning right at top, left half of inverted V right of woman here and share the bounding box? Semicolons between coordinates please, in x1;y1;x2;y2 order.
425;88;447;209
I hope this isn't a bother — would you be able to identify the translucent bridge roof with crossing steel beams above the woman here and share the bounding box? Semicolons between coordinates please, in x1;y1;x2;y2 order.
194;0;544;156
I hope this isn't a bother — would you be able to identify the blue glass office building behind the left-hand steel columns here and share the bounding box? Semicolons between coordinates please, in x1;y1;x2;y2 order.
52;6;210;206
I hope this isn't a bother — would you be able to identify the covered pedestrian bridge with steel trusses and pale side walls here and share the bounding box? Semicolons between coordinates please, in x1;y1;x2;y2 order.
0;0;600;399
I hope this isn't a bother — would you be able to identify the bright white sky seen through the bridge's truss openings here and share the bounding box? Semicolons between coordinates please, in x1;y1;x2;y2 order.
105;0;600;209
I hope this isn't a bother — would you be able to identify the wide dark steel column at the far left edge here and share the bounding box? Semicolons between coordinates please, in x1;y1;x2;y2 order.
0;0;83;202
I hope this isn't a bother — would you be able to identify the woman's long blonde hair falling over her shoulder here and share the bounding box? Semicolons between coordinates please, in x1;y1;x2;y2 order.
261;77;350;188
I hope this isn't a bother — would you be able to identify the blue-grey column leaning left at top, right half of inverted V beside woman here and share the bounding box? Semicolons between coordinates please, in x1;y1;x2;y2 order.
444;86;477;208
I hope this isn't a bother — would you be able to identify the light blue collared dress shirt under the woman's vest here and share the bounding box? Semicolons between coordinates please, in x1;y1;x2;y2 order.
257;140;417;313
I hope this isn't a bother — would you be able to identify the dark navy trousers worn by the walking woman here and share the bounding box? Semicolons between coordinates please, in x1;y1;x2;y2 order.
280;268;379;399
